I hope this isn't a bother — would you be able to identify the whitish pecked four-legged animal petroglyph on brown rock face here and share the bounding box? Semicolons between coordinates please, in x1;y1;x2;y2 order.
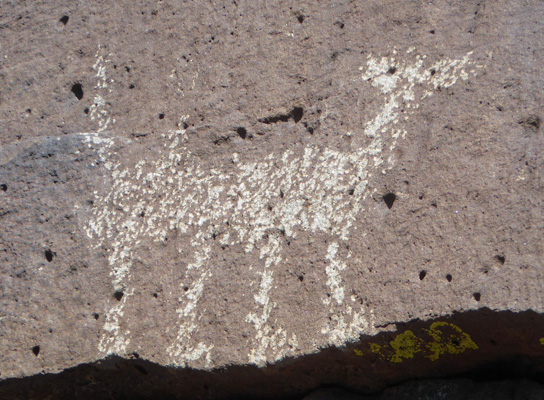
86;52;476;367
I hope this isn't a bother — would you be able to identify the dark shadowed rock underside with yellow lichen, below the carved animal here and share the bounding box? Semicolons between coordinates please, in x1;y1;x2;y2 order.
0;309;544;400
